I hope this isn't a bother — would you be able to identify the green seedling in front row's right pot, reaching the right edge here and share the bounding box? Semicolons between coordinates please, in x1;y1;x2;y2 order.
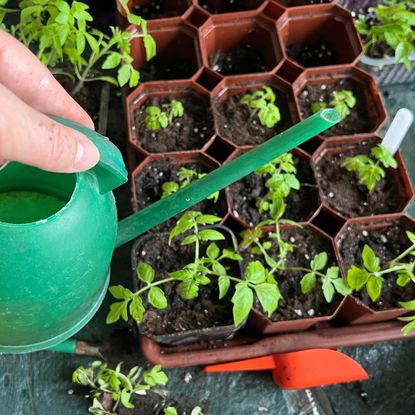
347;231;415;302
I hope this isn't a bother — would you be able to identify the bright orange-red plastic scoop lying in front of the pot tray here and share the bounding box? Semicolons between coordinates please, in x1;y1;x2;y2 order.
204;349;369;389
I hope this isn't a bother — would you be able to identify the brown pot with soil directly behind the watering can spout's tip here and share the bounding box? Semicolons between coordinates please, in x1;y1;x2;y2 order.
293;67;387;139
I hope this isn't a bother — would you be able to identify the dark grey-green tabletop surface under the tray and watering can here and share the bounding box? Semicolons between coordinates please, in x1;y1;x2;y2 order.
0;85;415;415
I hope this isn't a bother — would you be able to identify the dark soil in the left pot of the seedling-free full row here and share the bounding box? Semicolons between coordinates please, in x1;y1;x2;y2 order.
140;57;198;82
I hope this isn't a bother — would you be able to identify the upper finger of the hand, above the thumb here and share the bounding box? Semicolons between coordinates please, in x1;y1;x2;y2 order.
0;30;94;128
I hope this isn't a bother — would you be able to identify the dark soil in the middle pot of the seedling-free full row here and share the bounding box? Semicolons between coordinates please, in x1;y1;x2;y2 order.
209;41;270;75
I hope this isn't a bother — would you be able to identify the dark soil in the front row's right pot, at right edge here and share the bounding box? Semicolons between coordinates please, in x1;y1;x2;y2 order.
340;221;415;310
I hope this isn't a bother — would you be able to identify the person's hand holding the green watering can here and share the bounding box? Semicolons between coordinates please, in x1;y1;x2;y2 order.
0;30;99;173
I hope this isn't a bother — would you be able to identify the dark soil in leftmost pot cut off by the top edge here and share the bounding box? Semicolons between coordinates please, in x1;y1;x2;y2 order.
133;0;191;20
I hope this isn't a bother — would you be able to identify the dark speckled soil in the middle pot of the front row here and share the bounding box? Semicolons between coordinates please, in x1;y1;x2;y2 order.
242;227;340;322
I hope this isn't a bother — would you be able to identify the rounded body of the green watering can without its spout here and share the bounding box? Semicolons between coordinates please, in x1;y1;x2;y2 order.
0;118;127;353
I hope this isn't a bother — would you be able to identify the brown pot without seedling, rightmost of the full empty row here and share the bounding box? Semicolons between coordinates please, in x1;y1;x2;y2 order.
277;4;363;68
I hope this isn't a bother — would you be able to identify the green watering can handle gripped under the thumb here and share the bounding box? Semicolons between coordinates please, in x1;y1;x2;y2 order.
49;115;128;194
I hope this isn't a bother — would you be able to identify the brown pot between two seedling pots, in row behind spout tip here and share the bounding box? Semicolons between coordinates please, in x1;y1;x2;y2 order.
211;74;298;147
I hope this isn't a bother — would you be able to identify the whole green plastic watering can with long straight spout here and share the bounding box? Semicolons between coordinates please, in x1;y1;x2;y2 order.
0;109;340;353
